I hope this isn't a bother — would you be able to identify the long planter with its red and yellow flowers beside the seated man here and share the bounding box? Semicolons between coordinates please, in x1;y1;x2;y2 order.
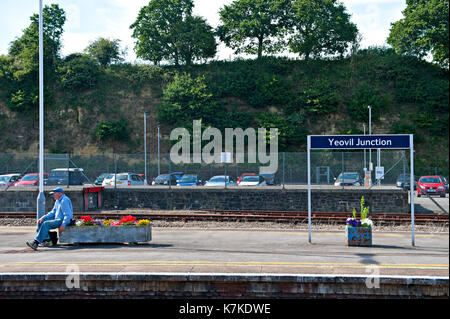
59;215;151;243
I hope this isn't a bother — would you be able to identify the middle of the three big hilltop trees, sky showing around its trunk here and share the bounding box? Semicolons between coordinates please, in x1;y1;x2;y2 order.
217;0;289;59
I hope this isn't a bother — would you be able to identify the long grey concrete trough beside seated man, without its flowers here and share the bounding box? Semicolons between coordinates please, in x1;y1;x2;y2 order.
59;225;152;243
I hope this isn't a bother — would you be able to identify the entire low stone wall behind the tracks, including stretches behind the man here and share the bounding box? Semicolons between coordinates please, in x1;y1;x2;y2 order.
0;187;410;213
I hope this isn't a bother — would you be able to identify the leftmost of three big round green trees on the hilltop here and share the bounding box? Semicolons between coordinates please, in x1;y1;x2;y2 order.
130;0;216;65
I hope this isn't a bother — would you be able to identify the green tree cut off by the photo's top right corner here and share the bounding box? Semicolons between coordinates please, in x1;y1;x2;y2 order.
387;0;449;69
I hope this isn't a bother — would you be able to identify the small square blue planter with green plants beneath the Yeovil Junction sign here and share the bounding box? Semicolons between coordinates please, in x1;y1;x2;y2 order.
345;196;373;246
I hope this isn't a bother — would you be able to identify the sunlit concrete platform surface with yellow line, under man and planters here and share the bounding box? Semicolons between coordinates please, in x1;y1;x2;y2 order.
0;226;449;278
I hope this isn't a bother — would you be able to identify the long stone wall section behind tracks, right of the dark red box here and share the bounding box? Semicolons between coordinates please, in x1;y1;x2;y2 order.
103;188;410;213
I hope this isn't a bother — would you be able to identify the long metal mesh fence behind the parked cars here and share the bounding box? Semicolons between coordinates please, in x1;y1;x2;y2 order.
0;151;449;186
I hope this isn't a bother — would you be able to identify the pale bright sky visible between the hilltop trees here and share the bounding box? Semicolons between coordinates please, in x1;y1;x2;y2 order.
0;0;406;63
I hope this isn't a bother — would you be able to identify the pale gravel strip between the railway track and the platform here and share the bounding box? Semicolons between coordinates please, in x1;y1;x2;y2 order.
0;218;449;233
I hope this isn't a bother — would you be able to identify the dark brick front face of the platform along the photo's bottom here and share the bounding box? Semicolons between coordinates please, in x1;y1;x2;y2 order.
0;273;448;299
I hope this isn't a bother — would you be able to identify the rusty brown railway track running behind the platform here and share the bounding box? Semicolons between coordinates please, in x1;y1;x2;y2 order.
0;210;449;225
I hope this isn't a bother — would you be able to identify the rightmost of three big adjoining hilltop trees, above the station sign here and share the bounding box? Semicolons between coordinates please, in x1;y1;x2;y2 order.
289;0;358;59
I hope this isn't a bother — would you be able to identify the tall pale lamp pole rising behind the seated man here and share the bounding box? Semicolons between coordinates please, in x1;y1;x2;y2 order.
36;0;45;219
